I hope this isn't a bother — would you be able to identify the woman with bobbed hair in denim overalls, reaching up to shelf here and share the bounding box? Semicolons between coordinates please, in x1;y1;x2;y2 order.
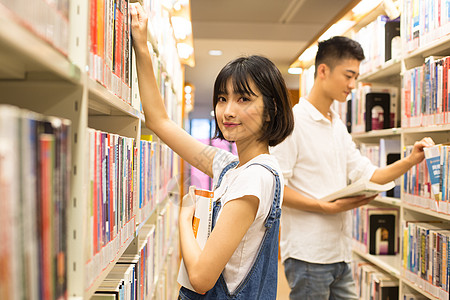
131;4;293;299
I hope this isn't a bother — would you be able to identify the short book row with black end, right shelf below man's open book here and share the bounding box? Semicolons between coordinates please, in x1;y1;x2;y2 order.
352;205;399;255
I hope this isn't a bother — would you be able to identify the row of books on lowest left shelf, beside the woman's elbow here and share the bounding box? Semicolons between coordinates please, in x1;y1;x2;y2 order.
91;199;179;300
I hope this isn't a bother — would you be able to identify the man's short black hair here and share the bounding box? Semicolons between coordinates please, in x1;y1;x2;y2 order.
314;36;365;77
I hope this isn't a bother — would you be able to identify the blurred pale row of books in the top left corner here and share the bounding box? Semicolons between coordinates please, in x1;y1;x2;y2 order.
0;0;70;56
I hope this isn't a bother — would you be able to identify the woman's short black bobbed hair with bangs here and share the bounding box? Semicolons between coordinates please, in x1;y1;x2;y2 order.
213;55;294;146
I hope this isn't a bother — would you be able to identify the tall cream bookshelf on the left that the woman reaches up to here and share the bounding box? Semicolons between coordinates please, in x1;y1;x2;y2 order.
0;0;184;299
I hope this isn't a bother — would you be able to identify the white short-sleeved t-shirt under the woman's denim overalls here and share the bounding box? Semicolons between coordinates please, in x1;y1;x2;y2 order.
213;150;284;293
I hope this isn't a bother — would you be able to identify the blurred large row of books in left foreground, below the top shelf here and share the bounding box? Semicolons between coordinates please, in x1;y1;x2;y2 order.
0;105;71;299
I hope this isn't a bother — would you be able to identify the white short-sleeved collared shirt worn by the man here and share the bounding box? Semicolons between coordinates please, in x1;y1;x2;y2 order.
270;98;376;264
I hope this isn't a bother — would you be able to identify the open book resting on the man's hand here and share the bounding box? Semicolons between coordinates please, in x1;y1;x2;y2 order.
320;179;395;201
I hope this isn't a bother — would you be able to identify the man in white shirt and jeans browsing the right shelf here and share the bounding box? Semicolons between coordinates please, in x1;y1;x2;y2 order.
271;37;434;300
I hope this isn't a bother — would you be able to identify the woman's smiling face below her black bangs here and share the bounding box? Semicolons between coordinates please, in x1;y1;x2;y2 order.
215;79;264;143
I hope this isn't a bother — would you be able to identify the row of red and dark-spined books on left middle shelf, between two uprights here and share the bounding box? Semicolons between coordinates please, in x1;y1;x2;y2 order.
86;129;137;286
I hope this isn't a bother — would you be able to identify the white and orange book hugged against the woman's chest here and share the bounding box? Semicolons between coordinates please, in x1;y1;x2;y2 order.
177;188;214;292
